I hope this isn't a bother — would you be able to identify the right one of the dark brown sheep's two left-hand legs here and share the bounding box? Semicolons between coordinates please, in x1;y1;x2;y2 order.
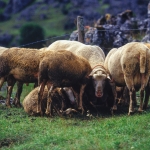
45;85;54;116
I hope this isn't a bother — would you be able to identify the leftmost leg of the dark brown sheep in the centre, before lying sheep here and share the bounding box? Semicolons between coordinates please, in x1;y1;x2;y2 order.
37;80;46;114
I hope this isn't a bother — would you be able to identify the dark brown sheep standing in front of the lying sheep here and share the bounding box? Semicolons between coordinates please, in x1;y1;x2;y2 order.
37;50;92;116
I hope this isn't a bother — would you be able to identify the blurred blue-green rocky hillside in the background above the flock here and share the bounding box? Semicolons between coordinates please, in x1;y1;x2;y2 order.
0;0;148;47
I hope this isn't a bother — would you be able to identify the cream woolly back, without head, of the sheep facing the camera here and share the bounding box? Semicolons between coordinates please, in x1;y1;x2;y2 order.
48;40;105;68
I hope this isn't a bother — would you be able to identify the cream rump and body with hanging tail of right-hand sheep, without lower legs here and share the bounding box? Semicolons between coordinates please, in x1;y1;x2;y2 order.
105;42;148;86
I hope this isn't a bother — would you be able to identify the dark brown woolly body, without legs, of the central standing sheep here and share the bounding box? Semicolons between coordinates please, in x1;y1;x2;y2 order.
39;50;92;87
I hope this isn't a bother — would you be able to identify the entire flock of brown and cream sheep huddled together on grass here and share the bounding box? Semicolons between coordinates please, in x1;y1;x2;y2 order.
0;40;150;116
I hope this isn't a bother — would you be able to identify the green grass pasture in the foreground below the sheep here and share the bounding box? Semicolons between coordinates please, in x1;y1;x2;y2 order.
0;84;150;150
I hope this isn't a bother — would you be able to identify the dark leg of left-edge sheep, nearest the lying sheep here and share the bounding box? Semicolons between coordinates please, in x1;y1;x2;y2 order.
13;82;23;107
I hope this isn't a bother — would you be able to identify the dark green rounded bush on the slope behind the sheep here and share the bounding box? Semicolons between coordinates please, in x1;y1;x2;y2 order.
20;23;45;48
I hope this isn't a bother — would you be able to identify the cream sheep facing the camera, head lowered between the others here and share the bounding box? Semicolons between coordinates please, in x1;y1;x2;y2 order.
48;40;109;101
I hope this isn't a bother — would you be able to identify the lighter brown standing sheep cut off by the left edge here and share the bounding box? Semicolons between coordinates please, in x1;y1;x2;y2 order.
0;47;49;107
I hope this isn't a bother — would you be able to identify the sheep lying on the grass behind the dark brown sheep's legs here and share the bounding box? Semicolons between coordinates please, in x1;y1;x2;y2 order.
22;87;75;116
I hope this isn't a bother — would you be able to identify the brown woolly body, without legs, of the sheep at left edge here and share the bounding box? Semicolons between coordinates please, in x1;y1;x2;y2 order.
0;47;47;82
